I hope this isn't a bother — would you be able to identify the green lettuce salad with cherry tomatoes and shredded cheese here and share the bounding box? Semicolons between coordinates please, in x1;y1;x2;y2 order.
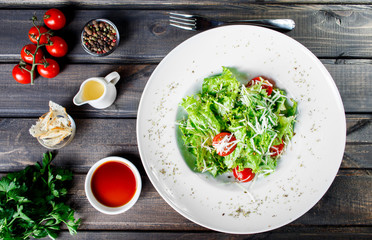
178;67;297;181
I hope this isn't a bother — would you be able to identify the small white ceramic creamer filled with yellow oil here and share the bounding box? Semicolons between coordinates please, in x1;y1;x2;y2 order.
73;72;120;109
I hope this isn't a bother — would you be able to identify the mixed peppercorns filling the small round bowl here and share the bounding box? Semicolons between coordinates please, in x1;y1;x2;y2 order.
83;20;117;54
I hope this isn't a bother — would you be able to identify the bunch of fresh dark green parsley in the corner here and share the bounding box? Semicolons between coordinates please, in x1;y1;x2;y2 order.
0;153;80;239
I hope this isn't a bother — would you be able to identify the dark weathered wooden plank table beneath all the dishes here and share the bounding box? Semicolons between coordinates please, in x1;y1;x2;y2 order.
0;0;372;239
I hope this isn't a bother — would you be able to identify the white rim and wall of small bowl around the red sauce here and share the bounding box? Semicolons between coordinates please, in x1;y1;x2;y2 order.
85;156;142;215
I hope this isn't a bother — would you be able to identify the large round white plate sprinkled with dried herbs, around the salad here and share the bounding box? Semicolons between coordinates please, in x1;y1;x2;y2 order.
137;25;346;234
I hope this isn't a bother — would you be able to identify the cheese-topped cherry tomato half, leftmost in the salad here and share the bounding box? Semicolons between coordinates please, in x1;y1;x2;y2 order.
212;132;236;157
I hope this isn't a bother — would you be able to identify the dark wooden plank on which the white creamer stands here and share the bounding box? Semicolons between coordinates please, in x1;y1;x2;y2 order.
0;59;372;118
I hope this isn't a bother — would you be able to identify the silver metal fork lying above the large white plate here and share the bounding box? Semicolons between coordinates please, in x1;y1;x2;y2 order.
169;12;295;31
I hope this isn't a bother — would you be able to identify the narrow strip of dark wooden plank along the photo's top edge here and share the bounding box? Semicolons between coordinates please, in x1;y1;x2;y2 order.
0;0;371;9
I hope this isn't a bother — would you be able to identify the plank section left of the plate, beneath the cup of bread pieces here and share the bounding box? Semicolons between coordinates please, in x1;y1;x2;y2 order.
0;118;140;174
